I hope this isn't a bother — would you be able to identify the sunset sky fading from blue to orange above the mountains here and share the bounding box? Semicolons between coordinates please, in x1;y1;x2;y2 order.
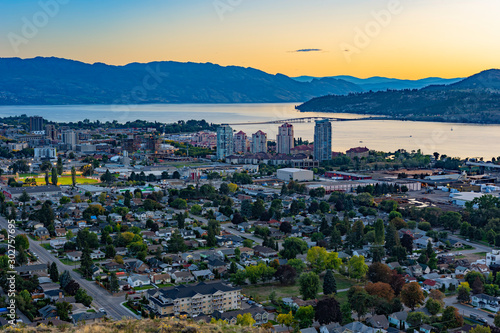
0;0;500;79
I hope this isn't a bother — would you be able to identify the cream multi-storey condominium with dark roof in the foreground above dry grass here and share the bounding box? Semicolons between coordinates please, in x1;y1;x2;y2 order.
147;282;241;317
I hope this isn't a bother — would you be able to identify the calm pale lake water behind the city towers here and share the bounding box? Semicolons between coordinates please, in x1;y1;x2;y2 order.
0;103;500;160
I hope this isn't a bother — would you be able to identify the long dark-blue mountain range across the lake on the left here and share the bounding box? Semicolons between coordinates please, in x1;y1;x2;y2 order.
0;57;362;105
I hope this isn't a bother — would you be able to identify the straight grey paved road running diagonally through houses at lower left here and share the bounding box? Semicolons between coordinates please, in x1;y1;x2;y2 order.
0;217;136;320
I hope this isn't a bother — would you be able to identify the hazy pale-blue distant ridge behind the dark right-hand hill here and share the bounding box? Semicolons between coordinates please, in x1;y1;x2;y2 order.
293;75;463;92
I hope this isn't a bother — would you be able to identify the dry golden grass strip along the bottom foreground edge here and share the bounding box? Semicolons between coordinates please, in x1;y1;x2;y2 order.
3;318;269;333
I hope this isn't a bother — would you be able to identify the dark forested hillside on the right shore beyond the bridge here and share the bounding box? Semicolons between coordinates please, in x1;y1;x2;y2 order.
297;69;500;124
